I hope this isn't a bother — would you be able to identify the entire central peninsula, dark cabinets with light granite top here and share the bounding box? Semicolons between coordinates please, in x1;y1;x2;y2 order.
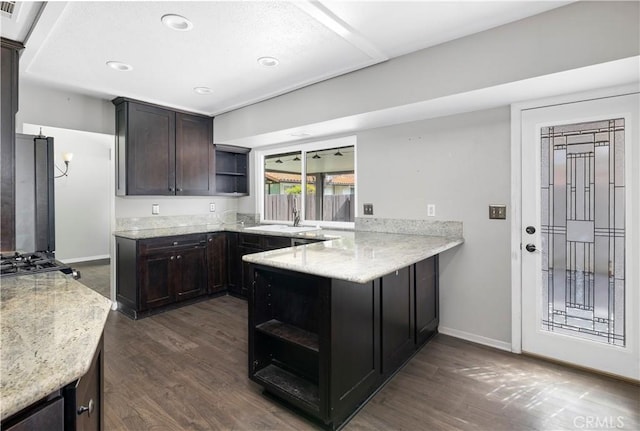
243;232;463;429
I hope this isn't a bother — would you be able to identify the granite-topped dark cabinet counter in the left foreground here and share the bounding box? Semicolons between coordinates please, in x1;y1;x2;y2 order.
0;271;111;430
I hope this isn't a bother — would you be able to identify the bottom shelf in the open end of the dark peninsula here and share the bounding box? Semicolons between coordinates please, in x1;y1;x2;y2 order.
254;364;320;412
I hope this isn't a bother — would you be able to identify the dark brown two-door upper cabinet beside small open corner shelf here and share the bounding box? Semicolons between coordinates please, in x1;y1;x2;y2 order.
113;97;215;196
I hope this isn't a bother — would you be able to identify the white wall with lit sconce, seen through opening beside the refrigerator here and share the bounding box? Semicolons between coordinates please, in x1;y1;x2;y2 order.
23;124;113;262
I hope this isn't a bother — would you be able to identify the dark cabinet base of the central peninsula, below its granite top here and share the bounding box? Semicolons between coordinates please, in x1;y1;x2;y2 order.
248;259;438;429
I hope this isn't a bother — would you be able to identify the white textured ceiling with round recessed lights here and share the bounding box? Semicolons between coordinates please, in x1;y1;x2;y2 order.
3;1;568;114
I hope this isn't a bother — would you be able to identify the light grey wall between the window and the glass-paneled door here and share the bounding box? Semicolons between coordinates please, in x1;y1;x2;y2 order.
357;107;511;348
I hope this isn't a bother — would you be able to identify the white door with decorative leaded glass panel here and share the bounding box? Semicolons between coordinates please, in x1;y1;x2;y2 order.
521;94;640;380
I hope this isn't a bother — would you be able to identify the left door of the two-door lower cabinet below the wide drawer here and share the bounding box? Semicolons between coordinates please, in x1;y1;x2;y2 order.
140;252;175;310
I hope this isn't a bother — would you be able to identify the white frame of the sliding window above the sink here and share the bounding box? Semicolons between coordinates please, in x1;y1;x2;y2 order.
254;135;359;229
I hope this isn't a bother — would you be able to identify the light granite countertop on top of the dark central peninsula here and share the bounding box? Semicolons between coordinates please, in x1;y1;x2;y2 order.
243;232;464;283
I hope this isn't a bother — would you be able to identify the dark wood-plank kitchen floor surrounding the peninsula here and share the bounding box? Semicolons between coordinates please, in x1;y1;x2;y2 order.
105;296;640;431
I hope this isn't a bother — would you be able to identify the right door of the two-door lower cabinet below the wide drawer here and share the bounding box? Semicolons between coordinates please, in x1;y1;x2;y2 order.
174;246;207;301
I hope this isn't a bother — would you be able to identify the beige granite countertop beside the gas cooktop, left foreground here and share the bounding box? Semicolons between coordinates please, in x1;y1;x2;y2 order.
0;271;111;419
